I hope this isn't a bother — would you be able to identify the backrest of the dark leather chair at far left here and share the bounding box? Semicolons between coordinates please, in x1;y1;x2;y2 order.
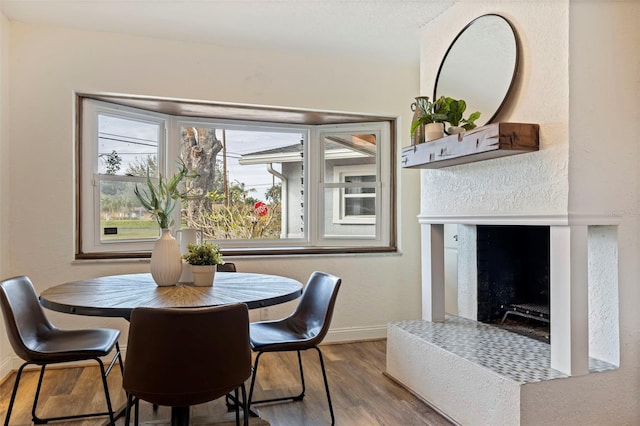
0;276;55;361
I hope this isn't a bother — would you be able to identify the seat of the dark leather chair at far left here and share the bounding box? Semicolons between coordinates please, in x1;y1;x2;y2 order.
25;328;120;362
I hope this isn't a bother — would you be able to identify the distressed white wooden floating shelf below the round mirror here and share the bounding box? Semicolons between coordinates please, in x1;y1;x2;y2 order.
401;123;540;169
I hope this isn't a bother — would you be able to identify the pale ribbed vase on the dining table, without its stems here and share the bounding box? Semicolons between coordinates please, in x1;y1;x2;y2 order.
151;229;182;286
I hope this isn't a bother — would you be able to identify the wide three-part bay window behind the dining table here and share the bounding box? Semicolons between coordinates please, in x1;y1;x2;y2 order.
77;96;395;258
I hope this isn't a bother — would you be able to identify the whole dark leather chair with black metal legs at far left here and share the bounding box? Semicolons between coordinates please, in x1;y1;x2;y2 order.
0;276;123;426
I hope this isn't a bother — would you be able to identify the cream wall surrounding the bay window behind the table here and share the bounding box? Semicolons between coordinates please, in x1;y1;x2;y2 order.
0;22;420;372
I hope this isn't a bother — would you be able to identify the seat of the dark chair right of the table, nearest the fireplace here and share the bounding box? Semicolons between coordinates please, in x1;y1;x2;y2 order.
249;320;317;352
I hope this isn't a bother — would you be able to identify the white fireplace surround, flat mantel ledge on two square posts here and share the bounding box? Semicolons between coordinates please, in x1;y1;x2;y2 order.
418;214;620;376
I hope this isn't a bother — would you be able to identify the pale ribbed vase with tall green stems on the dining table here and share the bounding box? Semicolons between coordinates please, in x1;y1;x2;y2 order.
133;160;199;286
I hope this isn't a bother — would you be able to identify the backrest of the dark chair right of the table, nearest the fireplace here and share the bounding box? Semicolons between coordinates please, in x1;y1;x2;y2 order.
289;271;342;344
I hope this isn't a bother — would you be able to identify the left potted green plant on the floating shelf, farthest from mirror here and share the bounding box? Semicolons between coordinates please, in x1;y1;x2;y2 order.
411;96;447;144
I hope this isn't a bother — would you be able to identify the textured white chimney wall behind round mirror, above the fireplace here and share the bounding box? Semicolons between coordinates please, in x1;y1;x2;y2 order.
420;1;569;214
